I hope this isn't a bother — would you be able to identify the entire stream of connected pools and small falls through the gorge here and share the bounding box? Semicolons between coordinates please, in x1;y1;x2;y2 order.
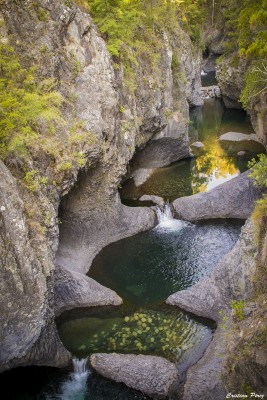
0;93;255;400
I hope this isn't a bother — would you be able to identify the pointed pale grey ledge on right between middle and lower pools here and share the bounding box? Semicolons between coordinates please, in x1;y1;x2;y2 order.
166;220;258;322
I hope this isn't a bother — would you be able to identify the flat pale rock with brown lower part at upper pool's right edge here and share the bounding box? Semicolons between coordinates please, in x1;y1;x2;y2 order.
219;132;265;154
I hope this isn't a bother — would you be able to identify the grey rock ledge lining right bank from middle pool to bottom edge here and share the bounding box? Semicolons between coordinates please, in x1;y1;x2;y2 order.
166;220;258;400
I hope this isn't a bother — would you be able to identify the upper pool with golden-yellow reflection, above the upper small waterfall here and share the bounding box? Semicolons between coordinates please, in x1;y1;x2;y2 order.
120;100;253;205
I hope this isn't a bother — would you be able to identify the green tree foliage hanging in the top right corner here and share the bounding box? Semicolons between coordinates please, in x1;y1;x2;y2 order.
220;0;267;108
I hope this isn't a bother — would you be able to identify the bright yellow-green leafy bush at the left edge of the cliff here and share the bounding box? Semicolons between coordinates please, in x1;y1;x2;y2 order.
0;44;62;159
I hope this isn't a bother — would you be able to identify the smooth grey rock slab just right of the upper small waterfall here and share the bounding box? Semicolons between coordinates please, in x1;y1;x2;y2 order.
172;171;262;221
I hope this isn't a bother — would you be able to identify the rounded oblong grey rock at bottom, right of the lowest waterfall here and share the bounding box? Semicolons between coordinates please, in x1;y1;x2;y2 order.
90;353;178;399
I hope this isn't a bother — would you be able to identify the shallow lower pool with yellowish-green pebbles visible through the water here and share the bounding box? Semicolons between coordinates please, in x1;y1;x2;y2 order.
58;305;216;371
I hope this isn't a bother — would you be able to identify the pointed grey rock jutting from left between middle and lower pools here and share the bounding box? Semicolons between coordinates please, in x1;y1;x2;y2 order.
55;267;122;316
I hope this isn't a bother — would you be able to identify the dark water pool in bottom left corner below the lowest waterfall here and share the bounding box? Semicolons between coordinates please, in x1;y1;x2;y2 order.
0;367;149;400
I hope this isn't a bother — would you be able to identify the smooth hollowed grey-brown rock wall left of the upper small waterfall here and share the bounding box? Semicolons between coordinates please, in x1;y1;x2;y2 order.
56;191;156;274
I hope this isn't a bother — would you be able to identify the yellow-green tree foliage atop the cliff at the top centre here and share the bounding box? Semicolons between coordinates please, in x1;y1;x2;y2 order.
87;0;204;89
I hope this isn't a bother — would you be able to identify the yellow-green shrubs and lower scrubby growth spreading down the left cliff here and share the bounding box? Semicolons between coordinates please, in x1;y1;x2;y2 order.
0;34;94;192
